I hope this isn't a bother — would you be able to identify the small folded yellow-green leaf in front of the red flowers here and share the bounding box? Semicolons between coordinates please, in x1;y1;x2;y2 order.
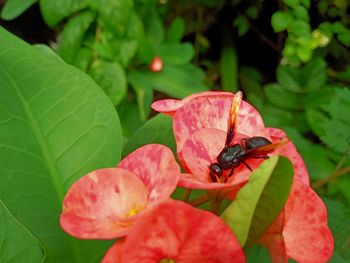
221;156;294;247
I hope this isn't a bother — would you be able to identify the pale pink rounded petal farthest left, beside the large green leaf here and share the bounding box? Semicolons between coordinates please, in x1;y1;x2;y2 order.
60;168;148;239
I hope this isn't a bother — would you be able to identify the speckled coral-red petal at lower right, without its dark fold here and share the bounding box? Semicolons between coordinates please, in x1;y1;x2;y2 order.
283;180;334;263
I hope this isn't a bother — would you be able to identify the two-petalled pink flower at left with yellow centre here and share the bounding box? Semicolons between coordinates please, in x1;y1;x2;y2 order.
60;144;180;239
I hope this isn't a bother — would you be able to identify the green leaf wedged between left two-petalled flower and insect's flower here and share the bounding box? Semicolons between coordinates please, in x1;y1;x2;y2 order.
123;114;176;156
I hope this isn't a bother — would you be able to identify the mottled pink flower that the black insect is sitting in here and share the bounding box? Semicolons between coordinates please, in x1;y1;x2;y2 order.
152;92;309;195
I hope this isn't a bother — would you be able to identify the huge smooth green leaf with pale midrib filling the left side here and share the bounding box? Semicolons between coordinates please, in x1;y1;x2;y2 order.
0;28;121;262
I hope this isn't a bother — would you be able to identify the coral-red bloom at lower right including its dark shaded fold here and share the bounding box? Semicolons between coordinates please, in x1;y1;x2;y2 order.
262;179;334;263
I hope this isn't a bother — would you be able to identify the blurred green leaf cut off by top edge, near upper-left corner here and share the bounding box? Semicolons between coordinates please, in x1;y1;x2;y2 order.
39;0;88;27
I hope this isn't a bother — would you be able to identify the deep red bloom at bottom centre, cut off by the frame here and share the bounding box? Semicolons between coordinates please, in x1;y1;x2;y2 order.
102;200;245;263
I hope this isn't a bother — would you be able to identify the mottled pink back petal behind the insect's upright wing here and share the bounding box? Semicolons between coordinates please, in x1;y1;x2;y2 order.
173;95;269;157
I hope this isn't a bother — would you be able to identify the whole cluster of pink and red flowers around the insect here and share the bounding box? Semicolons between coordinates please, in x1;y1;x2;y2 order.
60;92;333;263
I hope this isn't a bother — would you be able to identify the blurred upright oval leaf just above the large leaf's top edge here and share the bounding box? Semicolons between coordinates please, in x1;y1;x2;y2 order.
57;11;95;64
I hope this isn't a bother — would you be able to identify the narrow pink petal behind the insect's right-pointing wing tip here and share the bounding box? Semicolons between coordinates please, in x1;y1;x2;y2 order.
267;128;310;185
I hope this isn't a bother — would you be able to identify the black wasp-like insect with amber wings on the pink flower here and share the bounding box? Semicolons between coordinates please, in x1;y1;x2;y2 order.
209;91;289;183
